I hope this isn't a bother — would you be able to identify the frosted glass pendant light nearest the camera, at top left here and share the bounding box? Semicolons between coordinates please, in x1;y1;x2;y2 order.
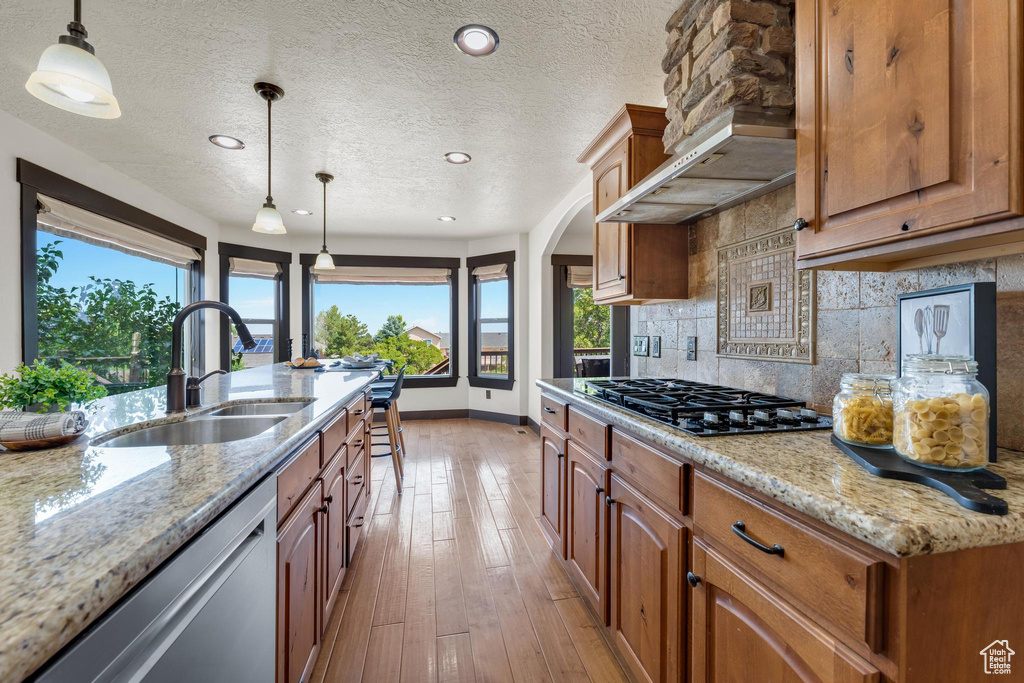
25;0;121;119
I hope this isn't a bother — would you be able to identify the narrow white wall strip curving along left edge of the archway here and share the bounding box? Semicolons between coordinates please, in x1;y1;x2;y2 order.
525;171;593;423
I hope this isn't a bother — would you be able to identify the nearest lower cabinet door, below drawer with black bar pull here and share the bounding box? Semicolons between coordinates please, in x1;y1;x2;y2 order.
690;540;881;683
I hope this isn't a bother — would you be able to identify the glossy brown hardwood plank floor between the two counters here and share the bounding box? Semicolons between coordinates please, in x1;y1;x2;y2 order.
311;420;627;683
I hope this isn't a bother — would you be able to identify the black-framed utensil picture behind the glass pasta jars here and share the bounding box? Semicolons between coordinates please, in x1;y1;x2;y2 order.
896;283;997;462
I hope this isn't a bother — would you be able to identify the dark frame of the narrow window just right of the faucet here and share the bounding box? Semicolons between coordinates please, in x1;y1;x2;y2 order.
217;242;292;371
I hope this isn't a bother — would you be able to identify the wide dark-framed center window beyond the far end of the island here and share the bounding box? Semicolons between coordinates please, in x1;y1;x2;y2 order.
300;254;460;387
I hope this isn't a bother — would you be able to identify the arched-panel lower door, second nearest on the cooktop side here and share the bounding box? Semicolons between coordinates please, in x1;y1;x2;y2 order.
607;474;684;682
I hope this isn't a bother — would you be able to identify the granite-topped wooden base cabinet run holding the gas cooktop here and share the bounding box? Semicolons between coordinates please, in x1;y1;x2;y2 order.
538;379;1024;682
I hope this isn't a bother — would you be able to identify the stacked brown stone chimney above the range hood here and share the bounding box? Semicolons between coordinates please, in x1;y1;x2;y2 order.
662;0;795;154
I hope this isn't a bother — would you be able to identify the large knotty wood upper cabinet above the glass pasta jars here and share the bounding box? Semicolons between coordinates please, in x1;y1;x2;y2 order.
795;0;1024;270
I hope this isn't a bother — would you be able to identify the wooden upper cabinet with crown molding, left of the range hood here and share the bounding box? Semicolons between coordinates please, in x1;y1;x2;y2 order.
578;104;687;304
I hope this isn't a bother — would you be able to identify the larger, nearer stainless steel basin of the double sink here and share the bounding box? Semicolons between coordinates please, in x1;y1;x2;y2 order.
95;415;286;449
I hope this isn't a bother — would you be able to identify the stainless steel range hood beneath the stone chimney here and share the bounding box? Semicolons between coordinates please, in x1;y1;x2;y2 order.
597;112;797;225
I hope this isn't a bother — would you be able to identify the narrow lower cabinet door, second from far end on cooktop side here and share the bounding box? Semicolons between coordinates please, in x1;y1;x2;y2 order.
565;441;608;625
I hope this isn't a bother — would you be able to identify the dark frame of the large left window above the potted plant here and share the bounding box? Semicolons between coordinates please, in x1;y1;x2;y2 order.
16;158;207;375
